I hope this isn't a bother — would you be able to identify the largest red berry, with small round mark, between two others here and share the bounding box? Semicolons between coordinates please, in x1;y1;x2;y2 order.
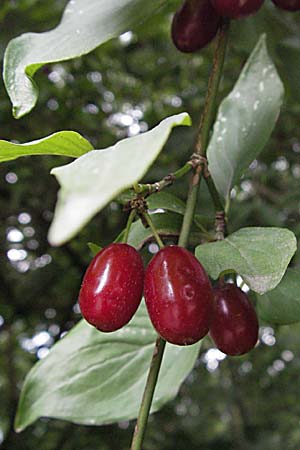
144;245;213;345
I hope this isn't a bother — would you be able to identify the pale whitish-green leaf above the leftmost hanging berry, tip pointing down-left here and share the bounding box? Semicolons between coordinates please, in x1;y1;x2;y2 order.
49;113;191;245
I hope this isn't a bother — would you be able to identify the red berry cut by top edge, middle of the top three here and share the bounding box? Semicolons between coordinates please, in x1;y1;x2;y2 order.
211;0;264;19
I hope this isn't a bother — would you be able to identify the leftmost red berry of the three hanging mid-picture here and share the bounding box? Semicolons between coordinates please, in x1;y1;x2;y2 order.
79;244;144;331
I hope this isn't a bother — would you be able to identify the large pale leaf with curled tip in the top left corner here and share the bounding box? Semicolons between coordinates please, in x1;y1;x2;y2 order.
4;0;166;118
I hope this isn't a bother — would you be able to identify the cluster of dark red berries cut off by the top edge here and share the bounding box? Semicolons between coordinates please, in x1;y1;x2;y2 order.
172;0;300;53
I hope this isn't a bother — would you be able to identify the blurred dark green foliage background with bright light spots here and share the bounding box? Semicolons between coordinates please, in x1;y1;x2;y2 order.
0;0;300;450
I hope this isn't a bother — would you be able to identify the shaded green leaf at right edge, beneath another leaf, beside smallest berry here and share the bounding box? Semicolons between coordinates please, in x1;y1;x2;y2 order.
256;269;300;325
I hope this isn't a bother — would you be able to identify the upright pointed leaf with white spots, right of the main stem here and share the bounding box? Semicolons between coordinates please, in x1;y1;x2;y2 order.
207;35;284;201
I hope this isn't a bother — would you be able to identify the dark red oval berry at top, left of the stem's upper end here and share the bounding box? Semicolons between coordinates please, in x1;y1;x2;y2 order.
171;0;221;53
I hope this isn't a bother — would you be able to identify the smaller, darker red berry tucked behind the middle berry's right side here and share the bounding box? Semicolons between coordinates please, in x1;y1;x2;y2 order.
210;284;258;356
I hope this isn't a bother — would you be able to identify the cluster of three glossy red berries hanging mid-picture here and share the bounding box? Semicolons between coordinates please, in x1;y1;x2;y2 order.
79;244;258;355
